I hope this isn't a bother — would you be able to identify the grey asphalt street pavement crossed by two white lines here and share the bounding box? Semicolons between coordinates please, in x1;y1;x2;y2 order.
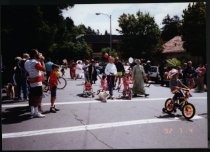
2;70;208;150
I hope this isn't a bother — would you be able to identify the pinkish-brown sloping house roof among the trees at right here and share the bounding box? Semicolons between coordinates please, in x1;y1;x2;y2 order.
162;36;186;53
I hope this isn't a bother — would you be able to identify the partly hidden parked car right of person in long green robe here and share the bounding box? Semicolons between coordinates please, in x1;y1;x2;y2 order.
148;66;160;83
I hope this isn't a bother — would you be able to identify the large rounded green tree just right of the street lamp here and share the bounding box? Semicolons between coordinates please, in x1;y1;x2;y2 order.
118;11;160;58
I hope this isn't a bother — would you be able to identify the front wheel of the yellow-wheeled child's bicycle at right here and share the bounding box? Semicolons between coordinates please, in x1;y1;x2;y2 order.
182;103;195;120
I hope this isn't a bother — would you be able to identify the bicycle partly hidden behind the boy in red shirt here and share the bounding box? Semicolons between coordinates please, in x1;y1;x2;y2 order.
42;77;67;92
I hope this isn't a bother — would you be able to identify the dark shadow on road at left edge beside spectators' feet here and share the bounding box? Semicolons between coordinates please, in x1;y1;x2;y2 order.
1;106;31;124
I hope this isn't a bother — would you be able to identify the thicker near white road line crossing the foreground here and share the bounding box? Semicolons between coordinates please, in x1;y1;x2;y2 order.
2;116;203;139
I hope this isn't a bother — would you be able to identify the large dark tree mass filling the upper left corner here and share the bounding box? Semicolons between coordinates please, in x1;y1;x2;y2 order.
1;5;96;82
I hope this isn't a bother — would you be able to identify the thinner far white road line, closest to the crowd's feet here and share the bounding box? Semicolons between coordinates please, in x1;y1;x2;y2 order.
2;97;207;108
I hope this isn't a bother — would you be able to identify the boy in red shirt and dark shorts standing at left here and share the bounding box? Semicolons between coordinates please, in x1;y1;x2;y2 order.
49;64;59;113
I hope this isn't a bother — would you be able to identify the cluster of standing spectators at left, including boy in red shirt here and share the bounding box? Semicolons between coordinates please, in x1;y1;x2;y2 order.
7;49;59;118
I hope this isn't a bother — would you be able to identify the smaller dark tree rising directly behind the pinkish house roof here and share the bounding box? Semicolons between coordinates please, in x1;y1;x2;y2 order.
161;15;181;41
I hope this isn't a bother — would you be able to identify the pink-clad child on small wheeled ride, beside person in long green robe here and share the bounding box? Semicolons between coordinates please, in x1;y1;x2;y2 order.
122;72;133;100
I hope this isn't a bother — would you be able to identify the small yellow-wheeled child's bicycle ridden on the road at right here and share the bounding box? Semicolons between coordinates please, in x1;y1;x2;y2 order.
162;88;195;120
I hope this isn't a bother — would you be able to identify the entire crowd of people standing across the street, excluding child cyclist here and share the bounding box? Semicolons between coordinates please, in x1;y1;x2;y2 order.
2;49;207;118
